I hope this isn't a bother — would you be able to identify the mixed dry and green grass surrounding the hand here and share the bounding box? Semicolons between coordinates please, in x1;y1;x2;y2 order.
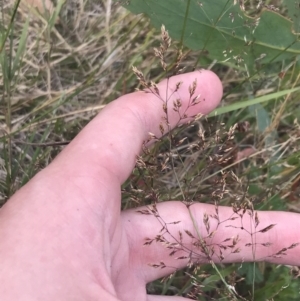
0;0;300;300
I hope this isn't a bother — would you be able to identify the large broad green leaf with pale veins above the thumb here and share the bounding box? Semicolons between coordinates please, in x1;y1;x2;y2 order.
125;0;300;74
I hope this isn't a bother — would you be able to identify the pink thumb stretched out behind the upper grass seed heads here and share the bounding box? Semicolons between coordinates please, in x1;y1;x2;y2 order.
56;70;223;184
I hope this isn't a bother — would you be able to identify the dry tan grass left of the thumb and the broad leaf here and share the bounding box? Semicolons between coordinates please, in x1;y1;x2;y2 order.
0;0;155;203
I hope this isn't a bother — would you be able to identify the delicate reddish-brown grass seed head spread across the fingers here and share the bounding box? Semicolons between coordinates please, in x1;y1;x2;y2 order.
129;22;298;300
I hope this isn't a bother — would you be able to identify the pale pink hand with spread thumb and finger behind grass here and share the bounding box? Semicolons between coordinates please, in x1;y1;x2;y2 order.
0;70;300;301
